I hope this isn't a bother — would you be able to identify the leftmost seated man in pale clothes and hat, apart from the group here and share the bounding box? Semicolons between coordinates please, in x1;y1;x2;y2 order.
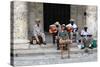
33;19;46;45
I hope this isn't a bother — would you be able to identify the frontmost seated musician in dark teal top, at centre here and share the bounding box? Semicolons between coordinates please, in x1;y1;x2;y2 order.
58;25;72;58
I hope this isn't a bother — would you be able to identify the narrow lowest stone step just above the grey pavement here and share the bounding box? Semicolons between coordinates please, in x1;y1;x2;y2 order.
14;52;97;60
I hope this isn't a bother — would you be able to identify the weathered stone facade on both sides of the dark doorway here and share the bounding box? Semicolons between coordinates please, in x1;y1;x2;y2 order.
11;1;97;49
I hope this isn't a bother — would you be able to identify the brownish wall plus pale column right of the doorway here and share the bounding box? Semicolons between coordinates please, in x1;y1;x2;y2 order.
70;5;98;38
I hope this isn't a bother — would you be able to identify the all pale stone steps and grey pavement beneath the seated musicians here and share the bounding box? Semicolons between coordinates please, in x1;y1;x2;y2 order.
13;43;97;66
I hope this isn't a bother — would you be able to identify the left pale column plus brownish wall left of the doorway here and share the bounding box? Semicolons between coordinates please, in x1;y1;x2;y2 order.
11;1;43;49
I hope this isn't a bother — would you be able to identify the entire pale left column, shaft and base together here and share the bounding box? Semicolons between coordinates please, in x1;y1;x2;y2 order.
13;1;29;49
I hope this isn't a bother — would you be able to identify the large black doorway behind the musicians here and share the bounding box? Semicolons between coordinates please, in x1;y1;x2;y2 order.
43;3;70;32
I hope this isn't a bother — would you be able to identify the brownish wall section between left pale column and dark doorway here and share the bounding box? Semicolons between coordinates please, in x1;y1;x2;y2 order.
28;2;43;38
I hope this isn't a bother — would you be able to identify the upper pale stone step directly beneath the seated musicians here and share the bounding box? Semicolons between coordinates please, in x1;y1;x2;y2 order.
13;45;97;56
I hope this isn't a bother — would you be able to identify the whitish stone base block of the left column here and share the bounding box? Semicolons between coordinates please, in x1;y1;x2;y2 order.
13;39;29;49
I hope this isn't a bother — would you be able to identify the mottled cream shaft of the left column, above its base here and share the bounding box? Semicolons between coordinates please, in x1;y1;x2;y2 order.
14;2;28;39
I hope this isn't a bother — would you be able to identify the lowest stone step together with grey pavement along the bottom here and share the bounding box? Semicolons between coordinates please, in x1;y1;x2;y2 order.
14;52;97;66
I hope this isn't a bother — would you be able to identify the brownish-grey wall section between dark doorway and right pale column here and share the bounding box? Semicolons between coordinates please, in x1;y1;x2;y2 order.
71;5;86;29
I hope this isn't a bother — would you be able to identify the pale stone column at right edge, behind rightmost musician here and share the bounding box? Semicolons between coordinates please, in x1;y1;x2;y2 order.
86;6;98;38
